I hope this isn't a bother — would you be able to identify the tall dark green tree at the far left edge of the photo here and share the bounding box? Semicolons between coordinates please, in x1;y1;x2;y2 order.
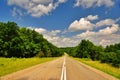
0;22;18;57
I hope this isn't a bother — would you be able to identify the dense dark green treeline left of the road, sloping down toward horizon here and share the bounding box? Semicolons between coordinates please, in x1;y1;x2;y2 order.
0;22;63;58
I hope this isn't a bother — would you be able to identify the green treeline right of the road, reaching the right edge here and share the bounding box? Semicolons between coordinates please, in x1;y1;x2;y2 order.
62;40;120;67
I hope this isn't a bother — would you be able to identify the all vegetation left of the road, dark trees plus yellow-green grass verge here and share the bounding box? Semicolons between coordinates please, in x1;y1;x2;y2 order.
0;22;63;76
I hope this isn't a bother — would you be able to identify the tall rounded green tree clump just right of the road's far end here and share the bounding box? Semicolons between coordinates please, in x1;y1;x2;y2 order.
67;40;103;60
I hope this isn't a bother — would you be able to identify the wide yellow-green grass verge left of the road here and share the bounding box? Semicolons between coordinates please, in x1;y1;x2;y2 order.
0;58;55;76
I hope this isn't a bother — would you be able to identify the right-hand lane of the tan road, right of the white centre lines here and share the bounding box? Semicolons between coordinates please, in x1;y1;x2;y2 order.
66;57;118;80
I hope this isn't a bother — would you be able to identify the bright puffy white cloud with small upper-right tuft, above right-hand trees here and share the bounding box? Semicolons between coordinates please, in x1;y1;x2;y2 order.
69;15;98;32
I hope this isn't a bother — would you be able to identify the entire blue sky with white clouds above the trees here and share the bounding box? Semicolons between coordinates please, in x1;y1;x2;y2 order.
0;0;120;47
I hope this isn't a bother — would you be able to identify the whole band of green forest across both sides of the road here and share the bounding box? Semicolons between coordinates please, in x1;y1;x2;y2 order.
0;22;120;67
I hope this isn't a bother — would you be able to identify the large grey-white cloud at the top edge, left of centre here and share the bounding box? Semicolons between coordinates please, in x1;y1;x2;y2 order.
8;0;66;17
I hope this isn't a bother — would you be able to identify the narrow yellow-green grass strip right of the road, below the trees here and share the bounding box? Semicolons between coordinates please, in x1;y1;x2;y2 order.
75;58;120;79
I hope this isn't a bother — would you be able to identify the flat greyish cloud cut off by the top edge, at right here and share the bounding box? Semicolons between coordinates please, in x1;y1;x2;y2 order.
74;0;114;8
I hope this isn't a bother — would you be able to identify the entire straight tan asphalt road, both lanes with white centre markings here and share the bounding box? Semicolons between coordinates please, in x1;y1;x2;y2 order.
0;56;117;80
